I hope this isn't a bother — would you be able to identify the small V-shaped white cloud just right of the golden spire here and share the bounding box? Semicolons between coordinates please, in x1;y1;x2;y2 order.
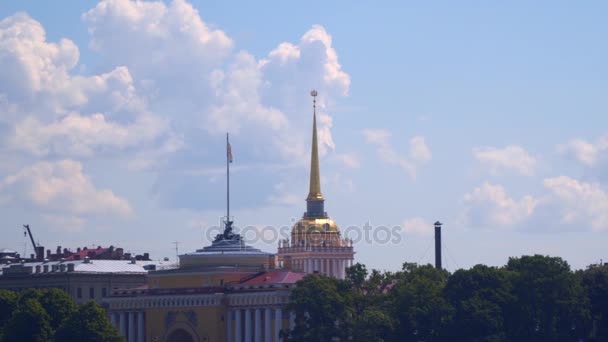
363;129;432;179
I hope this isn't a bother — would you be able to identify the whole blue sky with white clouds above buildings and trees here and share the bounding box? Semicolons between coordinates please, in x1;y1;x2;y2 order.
0;0;608;270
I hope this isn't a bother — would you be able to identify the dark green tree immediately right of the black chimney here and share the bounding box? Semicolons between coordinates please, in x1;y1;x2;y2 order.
444;265;514;342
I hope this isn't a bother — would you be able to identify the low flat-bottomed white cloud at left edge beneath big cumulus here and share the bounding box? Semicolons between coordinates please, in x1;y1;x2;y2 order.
0;160;133;216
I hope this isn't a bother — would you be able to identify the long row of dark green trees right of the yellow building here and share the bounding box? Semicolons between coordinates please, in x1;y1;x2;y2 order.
285;255;608;342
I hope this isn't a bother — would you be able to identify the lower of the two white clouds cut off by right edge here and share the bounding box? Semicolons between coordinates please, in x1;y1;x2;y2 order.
543;176;608;230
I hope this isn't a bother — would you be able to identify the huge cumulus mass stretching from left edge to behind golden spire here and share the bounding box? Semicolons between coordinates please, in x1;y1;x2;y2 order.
0;0;358;216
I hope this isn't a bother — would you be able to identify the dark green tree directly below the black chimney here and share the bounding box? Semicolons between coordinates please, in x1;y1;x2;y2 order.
389;263;451;341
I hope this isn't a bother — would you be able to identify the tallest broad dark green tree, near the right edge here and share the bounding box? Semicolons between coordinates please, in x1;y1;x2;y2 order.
505;255;590;341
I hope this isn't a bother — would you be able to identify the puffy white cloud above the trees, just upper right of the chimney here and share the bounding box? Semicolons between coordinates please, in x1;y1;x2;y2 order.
464;182;539;229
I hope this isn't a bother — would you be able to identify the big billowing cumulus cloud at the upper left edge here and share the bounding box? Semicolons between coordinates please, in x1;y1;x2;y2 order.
0;13;175;164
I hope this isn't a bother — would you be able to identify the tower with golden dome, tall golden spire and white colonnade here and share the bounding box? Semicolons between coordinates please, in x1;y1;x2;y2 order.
277;90;354;278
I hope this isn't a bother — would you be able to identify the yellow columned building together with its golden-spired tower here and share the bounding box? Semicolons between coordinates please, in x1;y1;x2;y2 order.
105;91;354;342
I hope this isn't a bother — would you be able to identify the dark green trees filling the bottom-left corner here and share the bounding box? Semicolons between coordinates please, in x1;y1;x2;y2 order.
0;289;124;342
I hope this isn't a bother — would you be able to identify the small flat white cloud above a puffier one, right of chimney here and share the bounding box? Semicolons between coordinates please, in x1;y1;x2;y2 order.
473;145;537;176
